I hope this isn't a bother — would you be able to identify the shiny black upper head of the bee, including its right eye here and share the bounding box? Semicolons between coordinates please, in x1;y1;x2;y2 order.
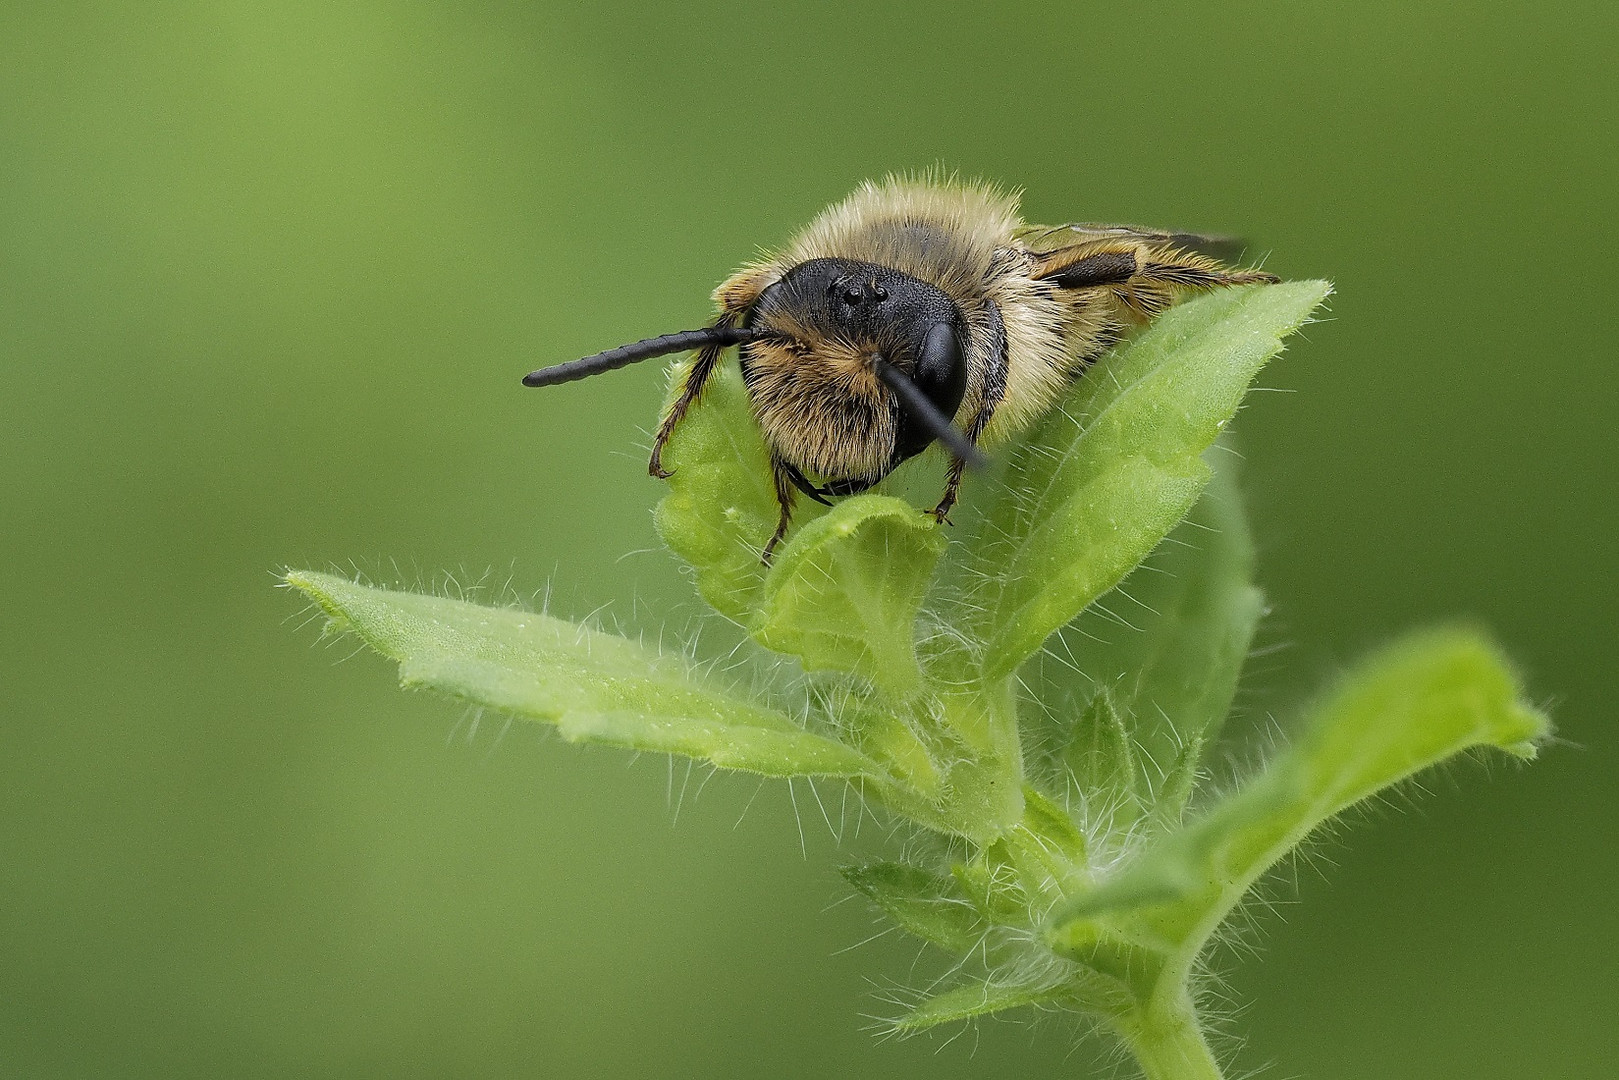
743;259;967;465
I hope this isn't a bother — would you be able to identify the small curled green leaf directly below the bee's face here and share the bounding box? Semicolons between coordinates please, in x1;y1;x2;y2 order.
753;495;945;696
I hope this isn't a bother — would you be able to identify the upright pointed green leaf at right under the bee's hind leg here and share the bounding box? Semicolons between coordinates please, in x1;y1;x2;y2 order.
965;282;1329;678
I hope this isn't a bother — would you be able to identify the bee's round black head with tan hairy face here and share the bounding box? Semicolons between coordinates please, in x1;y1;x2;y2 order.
742;259;967;481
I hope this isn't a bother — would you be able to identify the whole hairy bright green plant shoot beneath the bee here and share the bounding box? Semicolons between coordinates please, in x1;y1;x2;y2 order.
285;282;1549;1080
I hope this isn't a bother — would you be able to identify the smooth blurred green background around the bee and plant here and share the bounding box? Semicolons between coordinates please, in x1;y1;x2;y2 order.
0;0;1619;1080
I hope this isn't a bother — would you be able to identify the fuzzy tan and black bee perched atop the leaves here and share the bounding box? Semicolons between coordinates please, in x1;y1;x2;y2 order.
523;176;1277;562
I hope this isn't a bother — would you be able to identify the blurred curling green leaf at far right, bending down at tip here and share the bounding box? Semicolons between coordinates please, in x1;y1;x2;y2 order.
1052;630;1551;954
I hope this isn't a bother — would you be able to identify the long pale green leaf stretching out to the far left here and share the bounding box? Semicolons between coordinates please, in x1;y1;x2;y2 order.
287;570;877;777
